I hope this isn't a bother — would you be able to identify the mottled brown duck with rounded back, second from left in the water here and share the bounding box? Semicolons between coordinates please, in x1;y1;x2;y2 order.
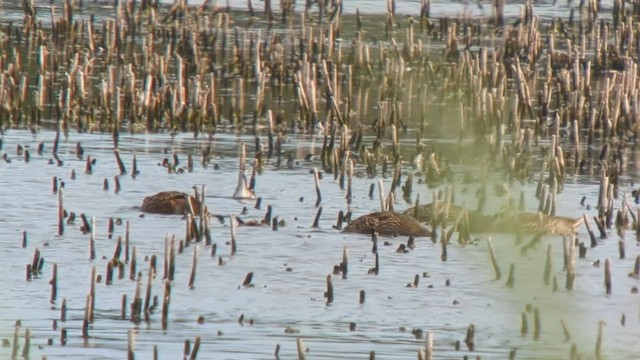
342;211;431;237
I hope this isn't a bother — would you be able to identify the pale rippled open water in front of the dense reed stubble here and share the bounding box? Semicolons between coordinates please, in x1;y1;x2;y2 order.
0;126;640;359
